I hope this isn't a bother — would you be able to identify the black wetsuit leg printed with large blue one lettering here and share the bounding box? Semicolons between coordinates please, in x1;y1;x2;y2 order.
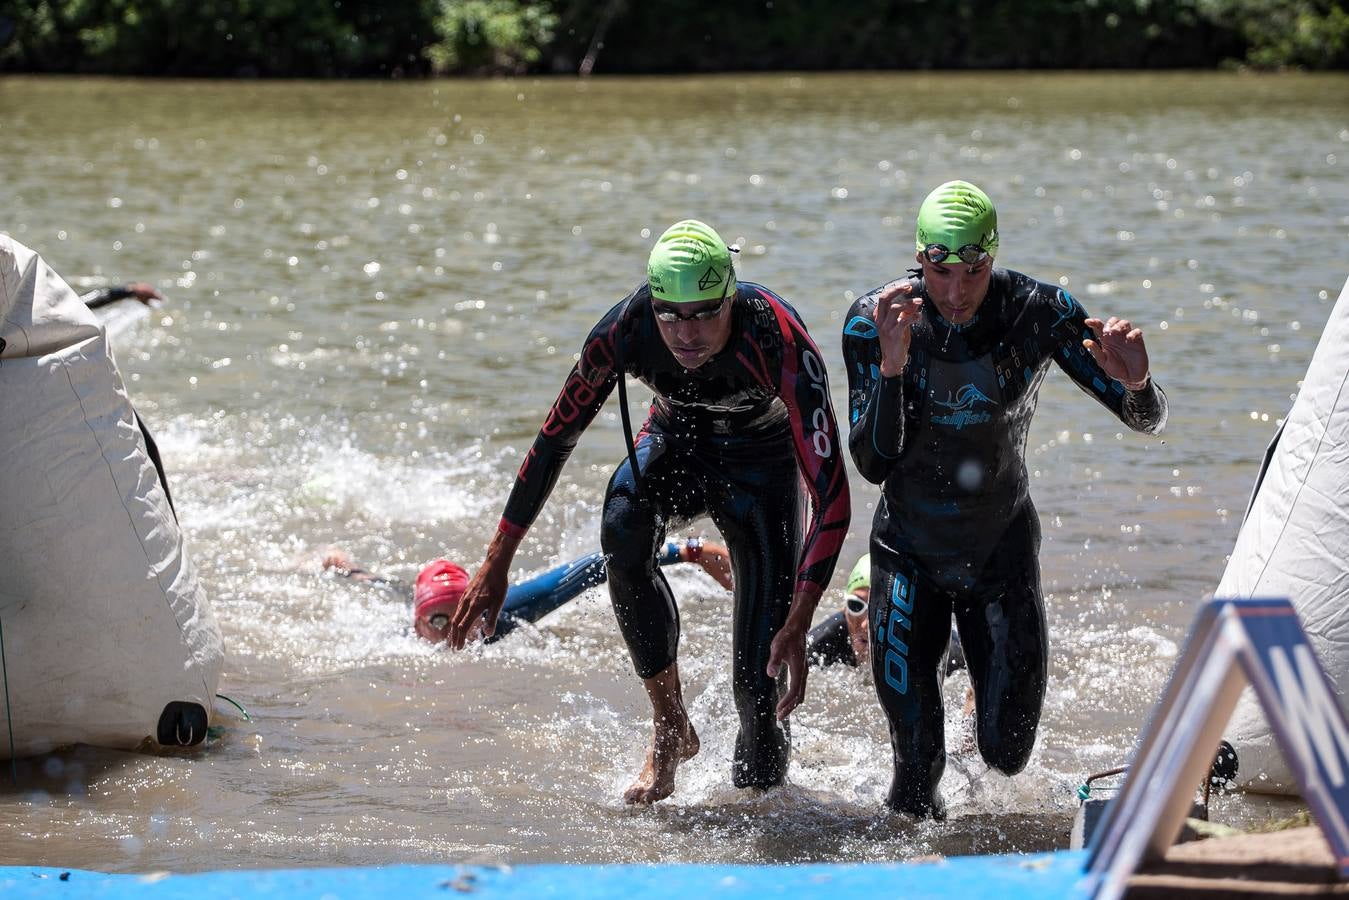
867;520;952;819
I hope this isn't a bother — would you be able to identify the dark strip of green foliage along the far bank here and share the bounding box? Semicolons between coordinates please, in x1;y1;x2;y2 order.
0;0;1349;77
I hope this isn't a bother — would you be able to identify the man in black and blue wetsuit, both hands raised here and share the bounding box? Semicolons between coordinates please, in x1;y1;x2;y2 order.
843;181;1167;818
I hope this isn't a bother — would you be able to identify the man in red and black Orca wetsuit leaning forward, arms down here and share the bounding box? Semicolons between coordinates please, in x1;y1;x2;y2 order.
451;220;849;803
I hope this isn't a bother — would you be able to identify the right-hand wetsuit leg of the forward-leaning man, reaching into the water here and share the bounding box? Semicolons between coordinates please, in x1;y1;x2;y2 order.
700;448;801;788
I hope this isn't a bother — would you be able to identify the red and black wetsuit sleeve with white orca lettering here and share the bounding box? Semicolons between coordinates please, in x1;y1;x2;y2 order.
773;304;851;600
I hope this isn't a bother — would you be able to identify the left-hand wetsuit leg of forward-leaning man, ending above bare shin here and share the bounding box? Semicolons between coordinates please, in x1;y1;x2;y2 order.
599;433;704;680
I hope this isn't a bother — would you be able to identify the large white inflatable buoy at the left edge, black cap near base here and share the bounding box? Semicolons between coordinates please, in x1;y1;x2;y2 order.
0;235;223;758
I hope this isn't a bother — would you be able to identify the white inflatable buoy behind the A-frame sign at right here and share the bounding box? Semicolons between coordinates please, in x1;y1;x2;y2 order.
1214;281;1349;795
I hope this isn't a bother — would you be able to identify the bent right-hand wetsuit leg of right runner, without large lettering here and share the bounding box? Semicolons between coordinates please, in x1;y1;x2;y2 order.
955;502;1050;775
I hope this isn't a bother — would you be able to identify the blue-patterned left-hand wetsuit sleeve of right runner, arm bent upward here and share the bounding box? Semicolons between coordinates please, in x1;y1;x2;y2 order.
843;297;904;484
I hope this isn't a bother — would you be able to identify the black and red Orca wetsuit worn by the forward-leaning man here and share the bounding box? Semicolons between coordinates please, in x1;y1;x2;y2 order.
500;282;849;787
